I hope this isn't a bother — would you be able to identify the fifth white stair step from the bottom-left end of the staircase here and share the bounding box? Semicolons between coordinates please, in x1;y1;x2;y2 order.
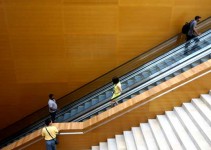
123;131;136;150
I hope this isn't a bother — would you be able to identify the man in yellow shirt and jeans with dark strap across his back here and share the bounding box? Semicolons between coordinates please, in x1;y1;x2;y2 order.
42;119;59;150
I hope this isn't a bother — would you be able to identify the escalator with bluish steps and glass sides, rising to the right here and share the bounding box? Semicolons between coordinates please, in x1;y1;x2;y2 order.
0;18;211;147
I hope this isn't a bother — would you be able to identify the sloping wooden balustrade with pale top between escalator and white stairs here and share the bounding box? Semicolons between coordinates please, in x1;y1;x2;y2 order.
3;60;211;150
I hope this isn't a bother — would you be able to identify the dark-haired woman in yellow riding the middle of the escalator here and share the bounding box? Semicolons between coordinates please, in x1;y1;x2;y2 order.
111;77;122;105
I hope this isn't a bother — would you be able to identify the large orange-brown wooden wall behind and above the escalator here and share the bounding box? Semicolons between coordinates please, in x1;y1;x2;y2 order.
0;0;211;129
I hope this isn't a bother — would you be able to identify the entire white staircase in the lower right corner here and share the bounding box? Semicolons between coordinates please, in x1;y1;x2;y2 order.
92;93;211;150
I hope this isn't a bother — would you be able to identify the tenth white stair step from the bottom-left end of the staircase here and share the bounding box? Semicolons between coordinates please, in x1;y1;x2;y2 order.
166;111;197;150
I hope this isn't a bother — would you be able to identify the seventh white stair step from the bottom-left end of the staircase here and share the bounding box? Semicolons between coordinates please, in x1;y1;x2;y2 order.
140;123;159;150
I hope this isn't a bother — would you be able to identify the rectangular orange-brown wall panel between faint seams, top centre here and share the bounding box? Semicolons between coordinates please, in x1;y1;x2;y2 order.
63;5;118;35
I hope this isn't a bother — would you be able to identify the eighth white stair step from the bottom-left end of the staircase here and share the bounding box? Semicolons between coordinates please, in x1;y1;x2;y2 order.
148;119;170;150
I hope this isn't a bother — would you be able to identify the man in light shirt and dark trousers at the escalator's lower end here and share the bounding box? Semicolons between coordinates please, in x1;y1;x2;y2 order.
48;94;57;122
